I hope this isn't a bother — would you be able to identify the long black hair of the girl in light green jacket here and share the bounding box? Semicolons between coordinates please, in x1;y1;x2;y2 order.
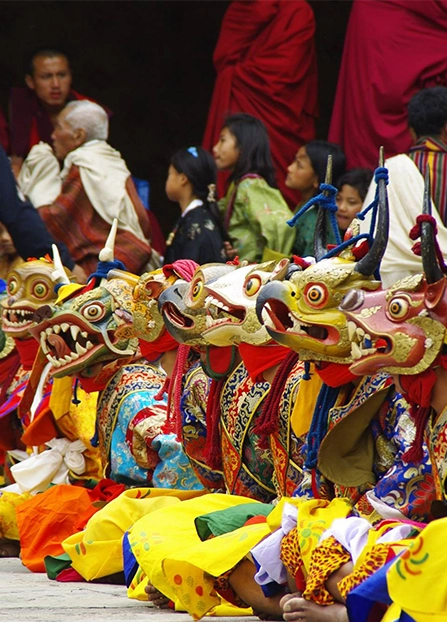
222;112;278;188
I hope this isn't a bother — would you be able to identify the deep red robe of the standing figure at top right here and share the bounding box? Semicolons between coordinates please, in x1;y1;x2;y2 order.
329;0;447;168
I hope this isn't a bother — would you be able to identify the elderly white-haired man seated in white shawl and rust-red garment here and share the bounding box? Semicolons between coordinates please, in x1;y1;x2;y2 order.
18;100;152;275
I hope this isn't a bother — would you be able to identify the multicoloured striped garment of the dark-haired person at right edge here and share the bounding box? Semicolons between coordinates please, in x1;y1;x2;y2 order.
408;136;447;225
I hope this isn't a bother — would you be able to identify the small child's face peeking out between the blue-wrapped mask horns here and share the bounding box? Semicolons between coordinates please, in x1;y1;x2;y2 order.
335;168;373;234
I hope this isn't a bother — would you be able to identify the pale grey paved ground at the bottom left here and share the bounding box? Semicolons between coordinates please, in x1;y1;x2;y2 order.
0;558;256;622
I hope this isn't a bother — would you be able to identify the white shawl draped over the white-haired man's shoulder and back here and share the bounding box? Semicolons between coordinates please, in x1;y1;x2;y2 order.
61;140;147;241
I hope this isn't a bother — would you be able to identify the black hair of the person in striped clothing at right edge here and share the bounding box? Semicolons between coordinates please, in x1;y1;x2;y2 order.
408;86;447;138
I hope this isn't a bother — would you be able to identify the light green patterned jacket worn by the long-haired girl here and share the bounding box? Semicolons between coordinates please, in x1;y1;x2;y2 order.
219;177;295;263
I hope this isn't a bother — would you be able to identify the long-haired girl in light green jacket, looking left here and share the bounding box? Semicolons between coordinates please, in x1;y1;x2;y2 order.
213;113;293;262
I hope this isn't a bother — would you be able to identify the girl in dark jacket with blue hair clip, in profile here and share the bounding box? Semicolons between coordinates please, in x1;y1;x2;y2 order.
164;147;227;264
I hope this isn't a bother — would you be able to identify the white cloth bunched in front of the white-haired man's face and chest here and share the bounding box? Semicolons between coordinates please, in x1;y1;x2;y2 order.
17;142;62;207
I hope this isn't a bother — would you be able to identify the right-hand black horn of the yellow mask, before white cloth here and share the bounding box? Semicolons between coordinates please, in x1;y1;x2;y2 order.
355;147;390;276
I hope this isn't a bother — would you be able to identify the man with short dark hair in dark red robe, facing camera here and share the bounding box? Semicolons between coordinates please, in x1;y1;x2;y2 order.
9;49;110;176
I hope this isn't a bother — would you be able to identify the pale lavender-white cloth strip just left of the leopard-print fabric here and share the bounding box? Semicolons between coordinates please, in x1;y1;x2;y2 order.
251;503;298;585
